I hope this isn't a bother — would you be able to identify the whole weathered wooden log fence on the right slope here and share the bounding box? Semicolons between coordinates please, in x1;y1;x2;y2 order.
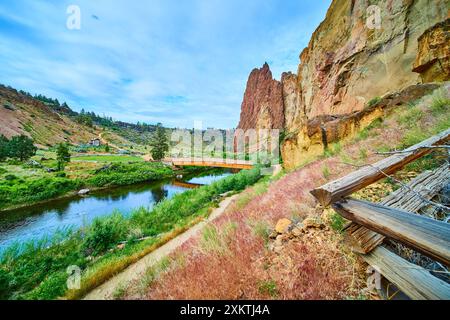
311;129;450;300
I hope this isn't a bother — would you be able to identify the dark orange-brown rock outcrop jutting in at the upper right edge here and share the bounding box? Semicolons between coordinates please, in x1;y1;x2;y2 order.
413;19;450;82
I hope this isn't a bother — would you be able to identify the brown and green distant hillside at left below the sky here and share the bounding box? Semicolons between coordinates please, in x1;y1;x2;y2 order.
0;84;160;149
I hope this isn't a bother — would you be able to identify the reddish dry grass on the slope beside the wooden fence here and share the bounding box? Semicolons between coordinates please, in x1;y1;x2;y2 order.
124;159;366;299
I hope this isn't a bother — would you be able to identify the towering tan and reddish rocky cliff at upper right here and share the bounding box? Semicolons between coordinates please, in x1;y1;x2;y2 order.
239;0;450;168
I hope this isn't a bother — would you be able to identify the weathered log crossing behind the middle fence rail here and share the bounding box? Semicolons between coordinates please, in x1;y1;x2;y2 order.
344;164;450;254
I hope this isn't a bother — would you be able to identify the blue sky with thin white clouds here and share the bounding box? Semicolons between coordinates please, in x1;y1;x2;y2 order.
0;0;331;129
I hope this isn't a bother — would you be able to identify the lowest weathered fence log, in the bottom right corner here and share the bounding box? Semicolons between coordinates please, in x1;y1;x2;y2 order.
362;247;450;300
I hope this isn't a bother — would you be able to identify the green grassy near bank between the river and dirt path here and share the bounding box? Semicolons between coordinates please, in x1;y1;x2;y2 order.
0;168;260;299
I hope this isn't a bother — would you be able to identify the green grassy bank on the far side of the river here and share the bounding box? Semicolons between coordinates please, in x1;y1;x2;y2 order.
0;162;207;214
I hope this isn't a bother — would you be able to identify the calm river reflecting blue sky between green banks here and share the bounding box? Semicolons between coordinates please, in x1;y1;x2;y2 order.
0;172;231;252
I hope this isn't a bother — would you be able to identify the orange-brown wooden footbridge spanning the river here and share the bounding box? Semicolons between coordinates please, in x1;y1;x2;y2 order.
164;158;254;169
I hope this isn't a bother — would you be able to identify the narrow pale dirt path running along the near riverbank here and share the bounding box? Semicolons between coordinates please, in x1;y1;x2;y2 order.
84;195;237;300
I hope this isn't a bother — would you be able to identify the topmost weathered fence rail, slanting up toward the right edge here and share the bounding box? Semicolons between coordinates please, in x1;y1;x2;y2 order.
311;129;450;206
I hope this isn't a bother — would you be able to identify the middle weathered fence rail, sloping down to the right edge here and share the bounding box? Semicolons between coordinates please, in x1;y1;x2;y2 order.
333;199;450;266
